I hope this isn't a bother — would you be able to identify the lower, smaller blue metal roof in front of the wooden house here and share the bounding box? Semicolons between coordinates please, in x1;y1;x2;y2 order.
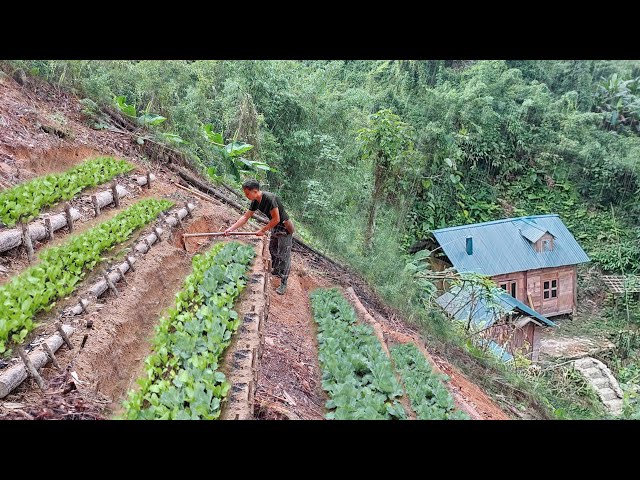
436;287;557;330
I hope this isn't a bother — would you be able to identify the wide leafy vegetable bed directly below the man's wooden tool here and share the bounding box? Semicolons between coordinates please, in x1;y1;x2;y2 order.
124;242;255;420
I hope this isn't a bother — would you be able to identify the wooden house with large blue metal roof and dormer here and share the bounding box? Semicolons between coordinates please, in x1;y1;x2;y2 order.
432;214;589;317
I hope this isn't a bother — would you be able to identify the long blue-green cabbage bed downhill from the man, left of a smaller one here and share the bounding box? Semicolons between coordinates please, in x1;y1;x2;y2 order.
311;289;406;420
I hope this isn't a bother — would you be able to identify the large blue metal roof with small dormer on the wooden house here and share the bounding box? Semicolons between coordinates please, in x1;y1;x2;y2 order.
432;214;590;276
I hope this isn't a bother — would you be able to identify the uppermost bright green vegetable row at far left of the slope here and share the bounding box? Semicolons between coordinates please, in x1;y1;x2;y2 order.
0;157;134;226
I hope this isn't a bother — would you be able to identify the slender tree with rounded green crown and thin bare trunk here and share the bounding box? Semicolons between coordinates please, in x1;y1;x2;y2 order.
357;109;414;250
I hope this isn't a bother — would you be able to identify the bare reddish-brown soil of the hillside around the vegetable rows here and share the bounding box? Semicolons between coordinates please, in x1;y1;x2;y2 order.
0;75;508;419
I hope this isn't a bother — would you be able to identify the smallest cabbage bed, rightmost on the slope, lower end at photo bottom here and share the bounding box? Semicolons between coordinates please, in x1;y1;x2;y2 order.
391;343;469;420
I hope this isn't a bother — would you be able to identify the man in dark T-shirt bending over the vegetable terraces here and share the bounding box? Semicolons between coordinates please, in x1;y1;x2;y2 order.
224;179;294;295
